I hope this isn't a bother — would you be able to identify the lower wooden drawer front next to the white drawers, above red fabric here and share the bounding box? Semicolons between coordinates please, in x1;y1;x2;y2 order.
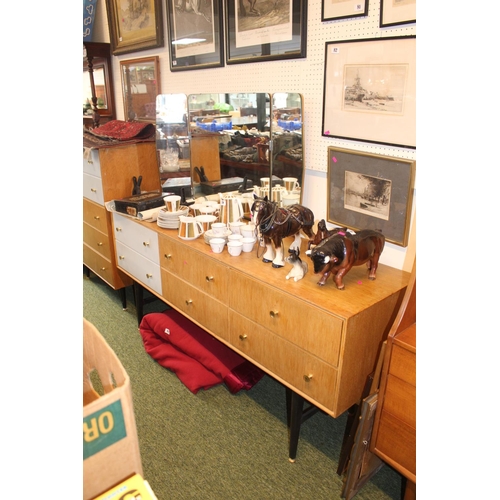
161;269;227;339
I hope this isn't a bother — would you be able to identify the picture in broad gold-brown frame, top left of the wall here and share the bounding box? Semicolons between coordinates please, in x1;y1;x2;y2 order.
106;0;164;55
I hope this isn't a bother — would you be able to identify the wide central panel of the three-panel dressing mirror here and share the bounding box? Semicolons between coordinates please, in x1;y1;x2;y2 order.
188;93;271;198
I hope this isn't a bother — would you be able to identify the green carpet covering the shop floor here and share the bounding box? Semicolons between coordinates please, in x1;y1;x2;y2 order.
83;274;401;500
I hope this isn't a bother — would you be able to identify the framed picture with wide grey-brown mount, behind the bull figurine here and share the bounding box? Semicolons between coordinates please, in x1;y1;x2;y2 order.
327;147;415;247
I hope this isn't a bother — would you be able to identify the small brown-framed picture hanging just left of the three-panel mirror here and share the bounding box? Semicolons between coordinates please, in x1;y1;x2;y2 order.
120;56;161;122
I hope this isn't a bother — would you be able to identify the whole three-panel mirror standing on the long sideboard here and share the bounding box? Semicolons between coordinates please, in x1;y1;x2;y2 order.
156;92;304;204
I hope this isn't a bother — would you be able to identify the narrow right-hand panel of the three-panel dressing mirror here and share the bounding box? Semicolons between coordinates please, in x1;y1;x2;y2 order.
271;92;304;205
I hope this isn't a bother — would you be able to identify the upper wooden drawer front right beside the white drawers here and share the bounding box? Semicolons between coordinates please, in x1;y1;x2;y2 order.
159;235;229;303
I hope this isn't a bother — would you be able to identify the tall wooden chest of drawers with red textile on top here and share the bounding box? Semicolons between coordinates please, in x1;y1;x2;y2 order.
83;142;161;296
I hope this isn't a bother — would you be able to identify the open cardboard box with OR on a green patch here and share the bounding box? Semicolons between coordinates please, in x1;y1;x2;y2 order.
83;319;143;500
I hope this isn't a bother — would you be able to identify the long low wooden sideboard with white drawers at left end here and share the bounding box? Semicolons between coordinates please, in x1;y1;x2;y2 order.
114;219;409;417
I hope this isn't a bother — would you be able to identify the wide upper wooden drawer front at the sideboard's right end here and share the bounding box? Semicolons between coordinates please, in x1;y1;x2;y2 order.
229;270;344;366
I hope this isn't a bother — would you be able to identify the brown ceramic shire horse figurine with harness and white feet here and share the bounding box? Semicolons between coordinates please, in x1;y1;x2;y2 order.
251;195;314;267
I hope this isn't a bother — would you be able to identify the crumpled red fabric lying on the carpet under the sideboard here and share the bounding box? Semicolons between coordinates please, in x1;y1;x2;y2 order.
139;309;264;394
